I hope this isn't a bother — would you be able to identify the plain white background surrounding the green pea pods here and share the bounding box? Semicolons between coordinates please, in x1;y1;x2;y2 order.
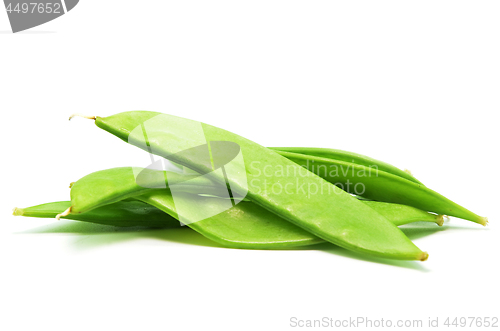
0;0;500;331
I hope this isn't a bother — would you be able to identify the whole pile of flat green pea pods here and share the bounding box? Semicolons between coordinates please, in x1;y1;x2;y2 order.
14;111;487;261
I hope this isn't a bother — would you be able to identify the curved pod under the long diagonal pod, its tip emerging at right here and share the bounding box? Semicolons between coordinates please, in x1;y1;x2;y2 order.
135;190;442;249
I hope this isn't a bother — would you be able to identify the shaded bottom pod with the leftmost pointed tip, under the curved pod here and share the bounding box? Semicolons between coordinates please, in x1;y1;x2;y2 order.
14;200;180;227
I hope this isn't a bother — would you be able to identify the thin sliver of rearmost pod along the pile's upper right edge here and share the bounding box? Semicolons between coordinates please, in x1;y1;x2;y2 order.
269;147;423;185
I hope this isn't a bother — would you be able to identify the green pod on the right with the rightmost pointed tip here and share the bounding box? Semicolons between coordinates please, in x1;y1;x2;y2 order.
277;151;488;225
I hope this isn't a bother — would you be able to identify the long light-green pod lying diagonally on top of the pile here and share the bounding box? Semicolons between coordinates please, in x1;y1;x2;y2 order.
75;111;428;260
